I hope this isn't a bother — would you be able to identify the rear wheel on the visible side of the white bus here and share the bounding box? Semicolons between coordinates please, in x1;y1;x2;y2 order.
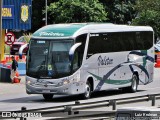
129;74;138;92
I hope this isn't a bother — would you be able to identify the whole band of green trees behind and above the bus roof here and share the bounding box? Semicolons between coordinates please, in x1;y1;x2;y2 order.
32;0;160;41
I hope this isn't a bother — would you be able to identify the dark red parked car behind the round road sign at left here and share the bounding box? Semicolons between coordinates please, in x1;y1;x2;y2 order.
10;36;28;55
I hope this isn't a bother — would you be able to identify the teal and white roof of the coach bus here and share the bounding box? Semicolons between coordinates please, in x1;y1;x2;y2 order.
32;23;153;38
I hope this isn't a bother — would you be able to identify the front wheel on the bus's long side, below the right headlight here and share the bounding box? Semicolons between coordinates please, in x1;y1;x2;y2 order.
83;81;91;99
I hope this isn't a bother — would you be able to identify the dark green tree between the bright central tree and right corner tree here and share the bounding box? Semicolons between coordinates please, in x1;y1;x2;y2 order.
99;0;136;24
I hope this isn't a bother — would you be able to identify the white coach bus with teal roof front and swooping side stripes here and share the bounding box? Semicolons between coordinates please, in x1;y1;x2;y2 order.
26;23;154;99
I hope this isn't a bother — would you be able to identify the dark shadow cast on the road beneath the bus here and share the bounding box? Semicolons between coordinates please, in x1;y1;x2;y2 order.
0;90;145;103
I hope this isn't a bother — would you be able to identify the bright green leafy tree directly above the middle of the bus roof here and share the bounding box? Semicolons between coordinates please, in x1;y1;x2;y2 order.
48;0;107;23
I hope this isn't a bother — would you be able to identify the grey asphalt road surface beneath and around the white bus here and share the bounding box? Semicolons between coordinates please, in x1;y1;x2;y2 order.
0;68;160;111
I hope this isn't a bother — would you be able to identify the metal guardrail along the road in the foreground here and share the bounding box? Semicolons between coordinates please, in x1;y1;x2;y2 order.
0;93;160;120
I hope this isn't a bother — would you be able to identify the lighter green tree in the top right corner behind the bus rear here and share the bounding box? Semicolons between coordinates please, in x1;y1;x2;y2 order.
132;0;160;38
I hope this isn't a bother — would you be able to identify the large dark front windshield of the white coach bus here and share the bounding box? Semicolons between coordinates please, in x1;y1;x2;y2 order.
27;39;73;78
